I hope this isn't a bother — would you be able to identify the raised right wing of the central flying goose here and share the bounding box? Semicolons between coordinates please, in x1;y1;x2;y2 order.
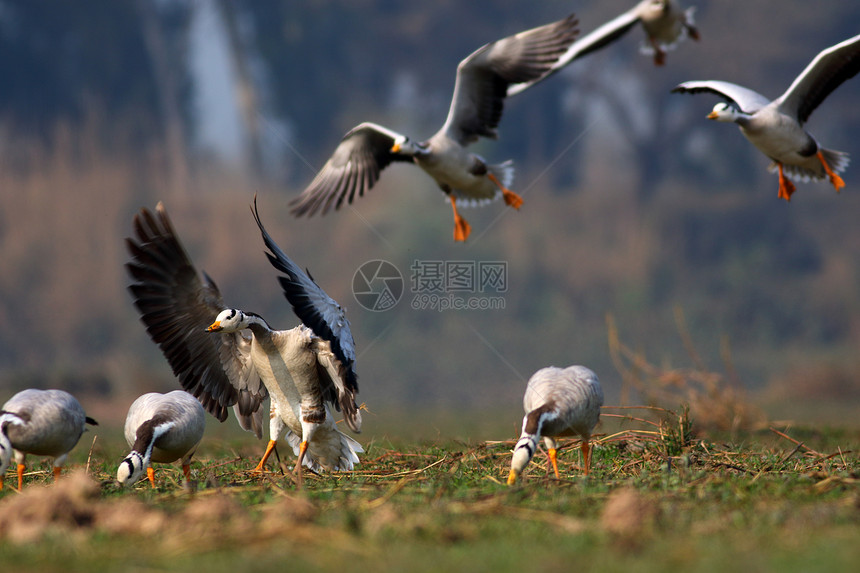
441;15;579;145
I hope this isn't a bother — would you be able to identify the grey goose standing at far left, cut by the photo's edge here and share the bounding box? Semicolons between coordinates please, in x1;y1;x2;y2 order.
0;388;98;491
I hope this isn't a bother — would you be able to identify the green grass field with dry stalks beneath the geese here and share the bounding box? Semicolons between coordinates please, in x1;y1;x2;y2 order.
0;406;860;572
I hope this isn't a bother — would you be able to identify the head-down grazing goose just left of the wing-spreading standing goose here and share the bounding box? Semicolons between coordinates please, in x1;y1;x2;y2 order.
116;390;206;487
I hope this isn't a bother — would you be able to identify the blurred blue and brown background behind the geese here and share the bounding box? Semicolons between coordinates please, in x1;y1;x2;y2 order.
0;0;860;438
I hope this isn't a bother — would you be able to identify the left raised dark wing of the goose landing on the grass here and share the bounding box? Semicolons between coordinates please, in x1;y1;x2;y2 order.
126;203;268;437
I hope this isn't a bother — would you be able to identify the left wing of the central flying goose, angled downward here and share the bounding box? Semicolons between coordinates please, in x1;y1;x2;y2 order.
290;123;412;217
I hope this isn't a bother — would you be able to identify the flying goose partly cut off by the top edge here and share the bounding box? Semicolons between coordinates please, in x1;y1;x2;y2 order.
508;0;699;96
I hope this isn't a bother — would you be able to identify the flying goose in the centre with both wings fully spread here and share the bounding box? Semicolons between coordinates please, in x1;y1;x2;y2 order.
291;15;578;241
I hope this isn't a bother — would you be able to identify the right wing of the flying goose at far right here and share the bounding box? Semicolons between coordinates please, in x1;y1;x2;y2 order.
777;35;860;123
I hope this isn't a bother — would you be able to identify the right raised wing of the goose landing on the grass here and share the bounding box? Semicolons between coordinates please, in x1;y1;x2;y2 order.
252;196;358;392
